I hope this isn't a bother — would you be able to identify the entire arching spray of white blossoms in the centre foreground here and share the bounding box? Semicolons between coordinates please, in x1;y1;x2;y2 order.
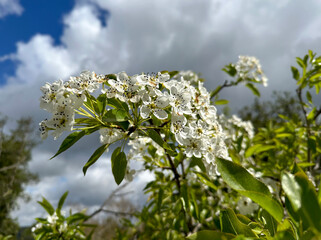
39;71;228;176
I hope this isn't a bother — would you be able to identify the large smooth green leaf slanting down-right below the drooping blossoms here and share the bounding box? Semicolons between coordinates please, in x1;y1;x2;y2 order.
216;158;283;222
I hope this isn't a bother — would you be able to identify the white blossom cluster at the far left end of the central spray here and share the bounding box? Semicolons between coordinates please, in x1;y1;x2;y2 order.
39;71;103;139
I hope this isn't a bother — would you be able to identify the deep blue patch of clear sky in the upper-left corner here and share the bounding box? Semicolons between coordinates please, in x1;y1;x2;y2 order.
0;0;75;85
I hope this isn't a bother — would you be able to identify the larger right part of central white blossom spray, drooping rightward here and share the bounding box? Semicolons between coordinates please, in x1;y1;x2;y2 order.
101;72;228;172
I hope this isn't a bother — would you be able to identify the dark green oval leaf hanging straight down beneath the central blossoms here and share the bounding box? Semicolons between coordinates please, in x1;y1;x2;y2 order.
111;147;127;185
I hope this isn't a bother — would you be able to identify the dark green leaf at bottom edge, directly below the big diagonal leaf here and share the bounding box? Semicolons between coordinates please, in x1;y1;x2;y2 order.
220;208;256;237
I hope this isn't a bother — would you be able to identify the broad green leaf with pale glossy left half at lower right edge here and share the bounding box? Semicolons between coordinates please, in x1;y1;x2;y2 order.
281;172;321;231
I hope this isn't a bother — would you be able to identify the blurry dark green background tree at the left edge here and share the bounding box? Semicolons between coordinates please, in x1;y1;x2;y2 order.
0;118;37;236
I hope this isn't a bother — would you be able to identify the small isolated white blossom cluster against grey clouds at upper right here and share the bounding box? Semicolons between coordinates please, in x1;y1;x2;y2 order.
235;56;268;87
